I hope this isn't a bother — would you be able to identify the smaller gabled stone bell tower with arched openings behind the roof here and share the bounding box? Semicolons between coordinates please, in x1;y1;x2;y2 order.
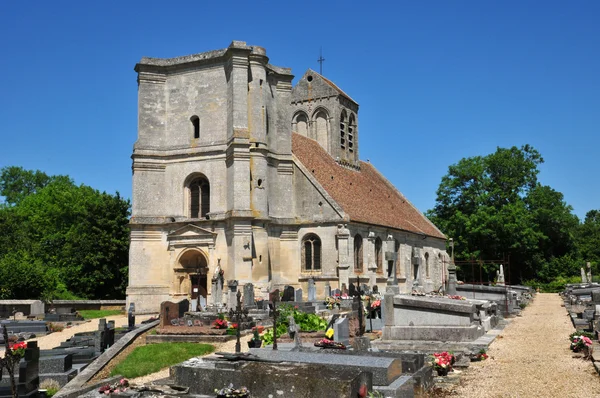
291;69;358;164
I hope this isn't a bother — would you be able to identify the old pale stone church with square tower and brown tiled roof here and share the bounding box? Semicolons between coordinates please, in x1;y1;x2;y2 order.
127;41;448;313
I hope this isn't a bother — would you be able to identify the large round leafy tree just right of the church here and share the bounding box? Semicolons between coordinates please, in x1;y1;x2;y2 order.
428;145;579;283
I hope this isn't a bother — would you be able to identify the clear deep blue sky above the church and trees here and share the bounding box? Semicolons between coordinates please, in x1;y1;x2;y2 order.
0;0;600;218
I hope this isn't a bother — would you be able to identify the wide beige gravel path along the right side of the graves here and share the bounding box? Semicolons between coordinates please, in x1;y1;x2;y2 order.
449;293;600;398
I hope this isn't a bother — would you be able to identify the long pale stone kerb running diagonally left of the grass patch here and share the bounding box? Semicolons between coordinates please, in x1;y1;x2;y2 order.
54;320;159;398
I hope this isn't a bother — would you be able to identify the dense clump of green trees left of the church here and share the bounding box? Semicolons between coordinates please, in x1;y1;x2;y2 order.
0;168;130;298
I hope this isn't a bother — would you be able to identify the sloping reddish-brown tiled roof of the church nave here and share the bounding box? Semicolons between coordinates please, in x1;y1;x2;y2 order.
292;133;446;239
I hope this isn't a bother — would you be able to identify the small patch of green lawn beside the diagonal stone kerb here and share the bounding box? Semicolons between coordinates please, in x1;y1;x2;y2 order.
111;343;215;379
